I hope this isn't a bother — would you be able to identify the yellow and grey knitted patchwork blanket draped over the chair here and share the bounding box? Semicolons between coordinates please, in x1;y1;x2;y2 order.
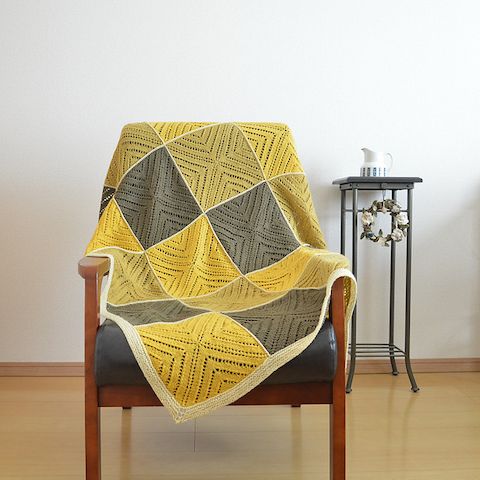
86;123;355;422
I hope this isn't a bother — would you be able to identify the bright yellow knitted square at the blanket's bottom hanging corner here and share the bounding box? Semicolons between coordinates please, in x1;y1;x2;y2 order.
137;313;268;407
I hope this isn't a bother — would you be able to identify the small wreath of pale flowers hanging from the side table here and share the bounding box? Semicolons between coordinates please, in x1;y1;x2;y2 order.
360;198;409;247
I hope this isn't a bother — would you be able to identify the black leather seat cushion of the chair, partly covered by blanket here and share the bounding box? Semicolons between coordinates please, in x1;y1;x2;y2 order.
95;320;337;386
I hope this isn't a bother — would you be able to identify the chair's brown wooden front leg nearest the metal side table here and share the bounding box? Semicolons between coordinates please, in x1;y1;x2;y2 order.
330;279;346;480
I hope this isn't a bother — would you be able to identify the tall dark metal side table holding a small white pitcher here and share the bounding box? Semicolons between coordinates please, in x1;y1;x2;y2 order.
333;177;423;393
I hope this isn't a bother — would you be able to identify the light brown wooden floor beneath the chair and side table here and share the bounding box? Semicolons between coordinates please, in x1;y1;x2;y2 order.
0;373;480;480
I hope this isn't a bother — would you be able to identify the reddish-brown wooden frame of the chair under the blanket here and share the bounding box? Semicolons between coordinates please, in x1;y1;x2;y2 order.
78;257;346;480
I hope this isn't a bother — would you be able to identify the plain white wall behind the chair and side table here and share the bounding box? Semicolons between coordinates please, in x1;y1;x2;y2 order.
0;0;480;361
